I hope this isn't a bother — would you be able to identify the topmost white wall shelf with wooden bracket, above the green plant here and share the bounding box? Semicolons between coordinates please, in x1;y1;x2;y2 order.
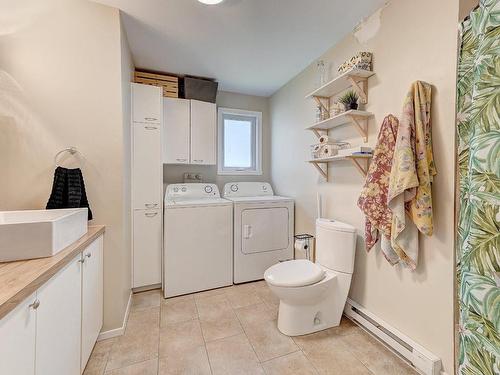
306;68;375;103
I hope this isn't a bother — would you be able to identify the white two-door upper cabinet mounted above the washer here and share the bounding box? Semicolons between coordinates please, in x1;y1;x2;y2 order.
163;98;217;165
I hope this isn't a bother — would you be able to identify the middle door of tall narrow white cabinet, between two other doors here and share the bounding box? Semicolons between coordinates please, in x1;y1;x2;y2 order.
132;124;163;209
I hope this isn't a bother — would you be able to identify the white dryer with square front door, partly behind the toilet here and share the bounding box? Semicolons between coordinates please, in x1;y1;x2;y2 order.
224;182;294;284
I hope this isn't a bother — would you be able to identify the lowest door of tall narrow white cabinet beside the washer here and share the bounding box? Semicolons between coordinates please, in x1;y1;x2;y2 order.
133;210;162;288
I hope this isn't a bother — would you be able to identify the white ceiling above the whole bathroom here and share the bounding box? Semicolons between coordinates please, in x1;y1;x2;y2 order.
94;0;384;96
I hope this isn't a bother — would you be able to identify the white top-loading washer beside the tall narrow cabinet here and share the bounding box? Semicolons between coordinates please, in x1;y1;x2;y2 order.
163;183;233;298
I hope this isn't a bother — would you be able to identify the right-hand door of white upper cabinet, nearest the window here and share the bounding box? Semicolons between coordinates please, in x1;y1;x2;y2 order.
191;100;217;165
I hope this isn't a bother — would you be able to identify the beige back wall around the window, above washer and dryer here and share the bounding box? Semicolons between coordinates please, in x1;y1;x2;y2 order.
163;91;271;189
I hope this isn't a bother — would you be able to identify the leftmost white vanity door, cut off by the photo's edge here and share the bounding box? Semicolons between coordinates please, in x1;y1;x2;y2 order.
0;294;36;375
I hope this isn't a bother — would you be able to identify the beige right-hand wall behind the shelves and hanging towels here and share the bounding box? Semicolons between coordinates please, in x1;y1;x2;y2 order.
270;0;458;375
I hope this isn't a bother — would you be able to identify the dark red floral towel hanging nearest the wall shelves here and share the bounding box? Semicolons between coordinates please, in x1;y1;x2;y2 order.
358;115;399;264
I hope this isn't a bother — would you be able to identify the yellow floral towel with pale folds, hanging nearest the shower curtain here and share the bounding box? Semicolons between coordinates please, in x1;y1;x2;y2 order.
387;81;437;269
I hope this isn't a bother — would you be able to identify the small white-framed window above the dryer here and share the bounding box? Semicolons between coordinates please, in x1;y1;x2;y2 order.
218;108;262;175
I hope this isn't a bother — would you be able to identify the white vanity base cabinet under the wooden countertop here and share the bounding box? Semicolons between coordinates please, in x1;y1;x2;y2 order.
0;235;103;375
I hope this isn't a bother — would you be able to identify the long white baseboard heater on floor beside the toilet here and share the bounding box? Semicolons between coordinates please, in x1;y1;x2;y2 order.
344;298;444;375
